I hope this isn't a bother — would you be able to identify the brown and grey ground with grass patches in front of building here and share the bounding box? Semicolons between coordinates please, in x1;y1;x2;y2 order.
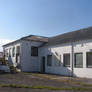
0;73;92;92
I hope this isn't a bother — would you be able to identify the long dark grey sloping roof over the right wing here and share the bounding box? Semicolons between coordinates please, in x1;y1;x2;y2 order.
47;27;92;45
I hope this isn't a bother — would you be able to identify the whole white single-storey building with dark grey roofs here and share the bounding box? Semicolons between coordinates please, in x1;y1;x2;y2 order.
3;27;92;78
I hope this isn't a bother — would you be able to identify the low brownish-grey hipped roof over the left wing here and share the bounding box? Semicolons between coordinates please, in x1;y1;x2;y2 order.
3;35;48;47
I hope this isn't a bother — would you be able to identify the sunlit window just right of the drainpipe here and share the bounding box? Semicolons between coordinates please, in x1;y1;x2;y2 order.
75;53;83;68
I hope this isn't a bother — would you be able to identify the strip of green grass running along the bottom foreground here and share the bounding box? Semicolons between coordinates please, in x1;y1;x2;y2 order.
0;84;92;91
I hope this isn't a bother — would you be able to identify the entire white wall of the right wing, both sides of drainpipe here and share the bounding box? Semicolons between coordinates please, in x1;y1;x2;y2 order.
40;40;92;78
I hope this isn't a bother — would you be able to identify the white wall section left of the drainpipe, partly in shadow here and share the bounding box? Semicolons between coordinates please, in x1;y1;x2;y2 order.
40;44;71;76
